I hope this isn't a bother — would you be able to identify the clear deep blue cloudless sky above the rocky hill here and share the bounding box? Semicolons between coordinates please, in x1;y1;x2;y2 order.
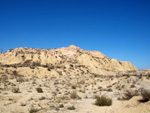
0;0;150;69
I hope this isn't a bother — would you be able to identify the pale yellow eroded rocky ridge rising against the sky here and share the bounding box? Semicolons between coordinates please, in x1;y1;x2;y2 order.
0;45;137;75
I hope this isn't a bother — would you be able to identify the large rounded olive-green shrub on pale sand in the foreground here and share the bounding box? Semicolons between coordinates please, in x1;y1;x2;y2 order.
95;96;112;106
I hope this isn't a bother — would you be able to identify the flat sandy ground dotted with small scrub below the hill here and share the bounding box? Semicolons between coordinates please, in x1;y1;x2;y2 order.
0;68;150;113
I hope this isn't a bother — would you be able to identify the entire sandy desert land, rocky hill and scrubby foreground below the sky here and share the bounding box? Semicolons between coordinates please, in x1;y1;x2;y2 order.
0;45;150;113
